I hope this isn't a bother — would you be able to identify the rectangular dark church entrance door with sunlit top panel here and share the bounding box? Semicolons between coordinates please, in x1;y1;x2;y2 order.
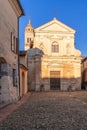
50;71;60;90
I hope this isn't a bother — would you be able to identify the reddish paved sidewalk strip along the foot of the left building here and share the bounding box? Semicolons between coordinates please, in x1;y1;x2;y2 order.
0;92;31;121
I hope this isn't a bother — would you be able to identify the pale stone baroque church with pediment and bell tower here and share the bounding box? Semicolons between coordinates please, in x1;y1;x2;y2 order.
25;18;81;91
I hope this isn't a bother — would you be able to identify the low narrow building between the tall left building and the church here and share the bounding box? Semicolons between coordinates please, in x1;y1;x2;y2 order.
19;51;29;97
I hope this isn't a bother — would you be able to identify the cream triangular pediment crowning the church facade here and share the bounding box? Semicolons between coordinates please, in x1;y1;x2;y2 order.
35;18;75;33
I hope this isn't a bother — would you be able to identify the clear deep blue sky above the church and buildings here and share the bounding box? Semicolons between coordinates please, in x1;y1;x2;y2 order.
19;0;87;56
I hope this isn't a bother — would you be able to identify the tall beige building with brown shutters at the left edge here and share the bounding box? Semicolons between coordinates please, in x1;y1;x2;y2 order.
0;0;24;103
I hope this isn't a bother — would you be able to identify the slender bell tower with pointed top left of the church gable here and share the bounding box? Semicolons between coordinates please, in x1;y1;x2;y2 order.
24;21;34;50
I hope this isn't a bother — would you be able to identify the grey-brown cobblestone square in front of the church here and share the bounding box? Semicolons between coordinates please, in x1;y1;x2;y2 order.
0;92;87;130
